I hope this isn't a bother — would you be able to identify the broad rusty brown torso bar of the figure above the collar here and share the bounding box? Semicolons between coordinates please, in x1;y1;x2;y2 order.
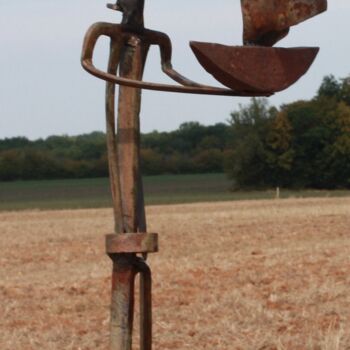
117;35;148;233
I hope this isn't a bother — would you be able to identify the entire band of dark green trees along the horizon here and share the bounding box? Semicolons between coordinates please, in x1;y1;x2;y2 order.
0;76;350;188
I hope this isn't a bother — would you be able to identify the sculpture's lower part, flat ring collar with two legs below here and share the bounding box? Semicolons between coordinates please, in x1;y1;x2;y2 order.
106;233;158;350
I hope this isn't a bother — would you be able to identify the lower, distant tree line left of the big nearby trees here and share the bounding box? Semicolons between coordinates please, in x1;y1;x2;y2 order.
0;122;230;181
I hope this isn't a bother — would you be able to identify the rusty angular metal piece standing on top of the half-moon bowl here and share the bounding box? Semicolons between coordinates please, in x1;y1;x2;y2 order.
241;0;327;46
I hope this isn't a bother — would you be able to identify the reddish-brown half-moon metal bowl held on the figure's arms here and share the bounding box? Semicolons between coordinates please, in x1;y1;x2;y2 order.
190;41;319;93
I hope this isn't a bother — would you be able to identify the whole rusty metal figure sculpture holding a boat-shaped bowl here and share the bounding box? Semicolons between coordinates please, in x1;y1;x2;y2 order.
81;0;327;350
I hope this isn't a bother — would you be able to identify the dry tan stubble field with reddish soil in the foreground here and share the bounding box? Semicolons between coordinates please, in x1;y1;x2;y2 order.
0;198;350;350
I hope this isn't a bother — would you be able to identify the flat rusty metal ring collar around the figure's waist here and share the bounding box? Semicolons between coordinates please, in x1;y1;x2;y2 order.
106;233;158;254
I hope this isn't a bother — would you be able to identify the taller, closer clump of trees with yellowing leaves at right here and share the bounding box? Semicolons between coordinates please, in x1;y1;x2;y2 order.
226;76;350;189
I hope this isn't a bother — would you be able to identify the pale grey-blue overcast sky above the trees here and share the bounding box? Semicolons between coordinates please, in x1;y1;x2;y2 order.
0;0;350;139
